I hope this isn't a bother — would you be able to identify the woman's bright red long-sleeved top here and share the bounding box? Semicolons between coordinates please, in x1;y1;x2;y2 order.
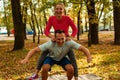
45;16;77;37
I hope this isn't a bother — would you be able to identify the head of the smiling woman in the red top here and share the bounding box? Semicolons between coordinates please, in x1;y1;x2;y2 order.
54;3;64;17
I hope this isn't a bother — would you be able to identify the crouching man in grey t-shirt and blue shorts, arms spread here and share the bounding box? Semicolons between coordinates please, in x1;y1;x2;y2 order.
21;30;92;80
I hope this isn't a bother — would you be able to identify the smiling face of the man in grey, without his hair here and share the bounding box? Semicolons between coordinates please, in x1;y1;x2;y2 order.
56;33;65;46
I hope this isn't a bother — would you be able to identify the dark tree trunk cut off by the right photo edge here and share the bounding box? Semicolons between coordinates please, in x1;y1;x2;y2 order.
113;0;120;45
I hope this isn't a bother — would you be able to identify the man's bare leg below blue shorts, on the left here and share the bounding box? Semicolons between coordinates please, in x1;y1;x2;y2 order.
41;64;50;80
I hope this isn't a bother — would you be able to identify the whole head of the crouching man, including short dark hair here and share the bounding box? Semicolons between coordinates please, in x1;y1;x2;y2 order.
55;30;65;46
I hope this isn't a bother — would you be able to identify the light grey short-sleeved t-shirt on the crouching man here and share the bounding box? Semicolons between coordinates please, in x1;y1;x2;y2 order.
39;40;81;61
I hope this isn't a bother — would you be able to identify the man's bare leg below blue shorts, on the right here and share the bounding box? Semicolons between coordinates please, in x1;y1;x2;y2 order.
65;64;74;80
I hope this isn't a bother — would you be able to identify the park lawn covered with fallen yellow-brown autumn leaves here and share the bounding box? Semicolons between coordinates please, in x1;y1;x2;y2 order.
0;32;120;80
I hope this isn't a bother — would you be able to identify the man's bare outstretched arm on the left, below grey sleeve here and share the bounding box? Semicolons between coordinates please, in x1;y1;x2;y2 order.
20;47;40;64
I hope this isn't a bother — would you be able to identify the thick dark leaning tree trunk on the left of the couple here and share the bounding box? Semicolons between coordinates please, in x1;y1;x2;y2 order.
11;0;24;50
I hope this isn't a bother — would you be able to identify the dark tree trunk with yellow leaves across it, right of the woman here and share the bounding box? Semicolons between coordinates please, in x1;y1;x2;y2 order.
86;0;99;46
